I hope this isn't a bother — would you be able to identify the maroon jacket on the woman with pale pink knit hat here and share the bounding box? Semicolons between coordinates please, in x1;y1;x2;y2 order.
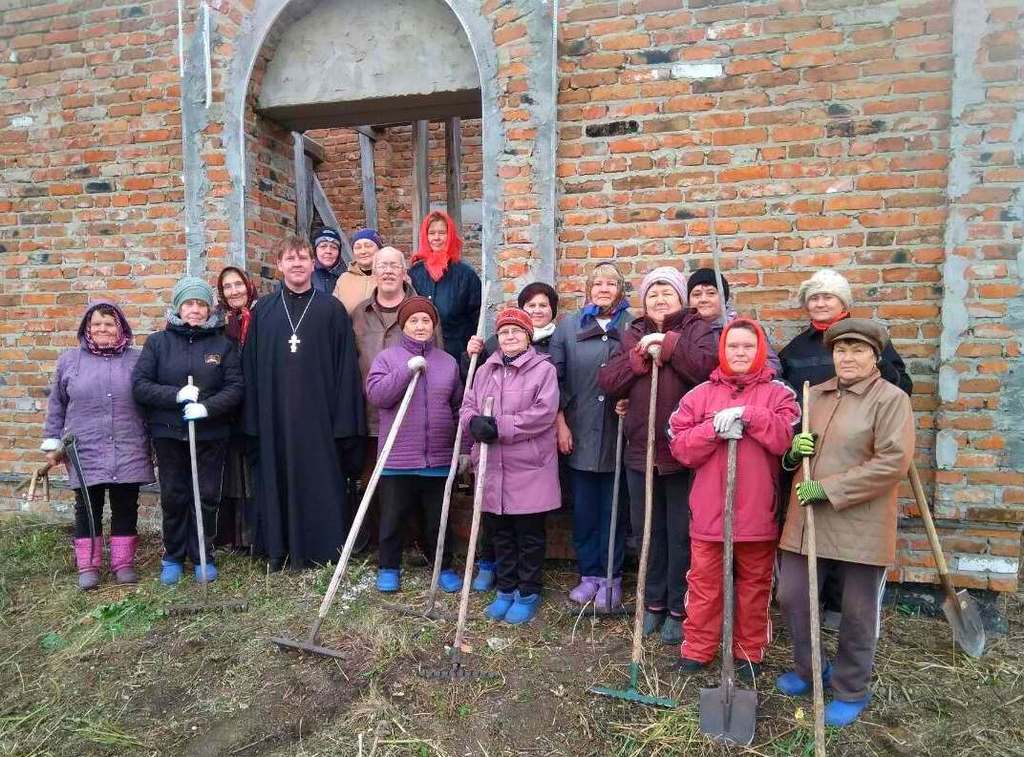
598;307;718;475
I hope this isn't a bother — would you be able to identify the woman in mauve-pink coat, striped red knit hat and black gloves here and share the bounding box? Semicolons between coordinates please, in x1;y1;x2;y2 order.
460;307;561;625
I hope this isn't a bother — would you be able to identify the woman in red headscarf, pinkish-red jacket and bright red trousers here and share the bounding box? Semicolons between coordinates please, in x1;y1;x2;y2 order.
669;319;800;681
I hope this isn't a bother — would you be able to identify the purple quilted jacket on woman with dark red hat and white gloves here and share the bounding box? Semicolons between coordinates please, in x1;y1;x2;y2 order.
366;334;462;470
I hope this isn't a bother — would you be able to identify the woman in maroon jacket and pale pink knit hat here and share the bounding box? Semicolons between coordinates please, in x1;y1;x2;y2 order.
598;266;718;644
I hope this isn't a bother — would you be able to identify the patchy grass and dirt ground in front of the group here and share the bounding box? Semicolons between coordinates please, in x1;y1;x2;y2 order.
0;520;1024;757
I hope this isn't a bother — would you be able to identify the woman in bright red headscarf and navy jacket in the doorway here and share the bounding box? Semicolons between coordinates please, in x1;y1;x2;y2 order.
409;210;481;361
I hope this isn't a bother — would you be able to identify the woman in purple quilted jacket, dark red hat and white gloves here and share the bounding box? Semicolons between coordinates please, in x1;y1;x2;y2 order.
366;297;462;592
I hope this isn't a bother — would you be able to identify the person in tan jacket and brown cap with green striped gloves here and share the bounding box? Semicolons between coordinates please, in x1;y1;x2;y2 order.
776;319;914;726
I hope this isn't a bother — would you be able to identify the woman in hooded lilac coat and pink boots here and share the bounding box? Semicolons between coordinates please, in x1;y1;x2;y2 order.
41;302;154;589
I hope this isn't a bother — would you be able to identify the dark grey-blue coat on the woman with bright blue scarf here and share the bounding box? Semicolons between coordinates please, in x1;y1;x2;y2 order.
550;310;629;473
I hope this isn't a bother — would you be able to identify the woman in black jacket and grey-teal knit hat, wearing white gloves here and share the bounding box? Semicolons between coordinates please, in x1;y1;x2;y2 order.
132;276;245;585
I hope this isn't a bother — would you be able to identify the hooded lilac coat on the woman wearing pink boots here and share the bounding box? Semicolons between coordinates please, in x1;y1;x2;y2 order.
43;302;156;489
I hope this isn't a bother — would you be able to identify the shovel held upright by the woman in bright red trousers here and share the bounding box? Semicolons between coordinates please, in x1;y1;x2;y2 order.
700;434;758;747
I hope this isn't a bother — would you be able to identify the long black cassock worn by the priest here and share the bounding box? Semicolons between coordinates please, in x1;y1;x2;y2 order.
245;287;366;570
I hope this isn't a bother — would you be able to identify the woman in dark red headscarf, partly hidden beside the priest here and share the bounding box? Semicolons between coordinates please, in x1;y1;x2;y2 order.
214;265;259;549
